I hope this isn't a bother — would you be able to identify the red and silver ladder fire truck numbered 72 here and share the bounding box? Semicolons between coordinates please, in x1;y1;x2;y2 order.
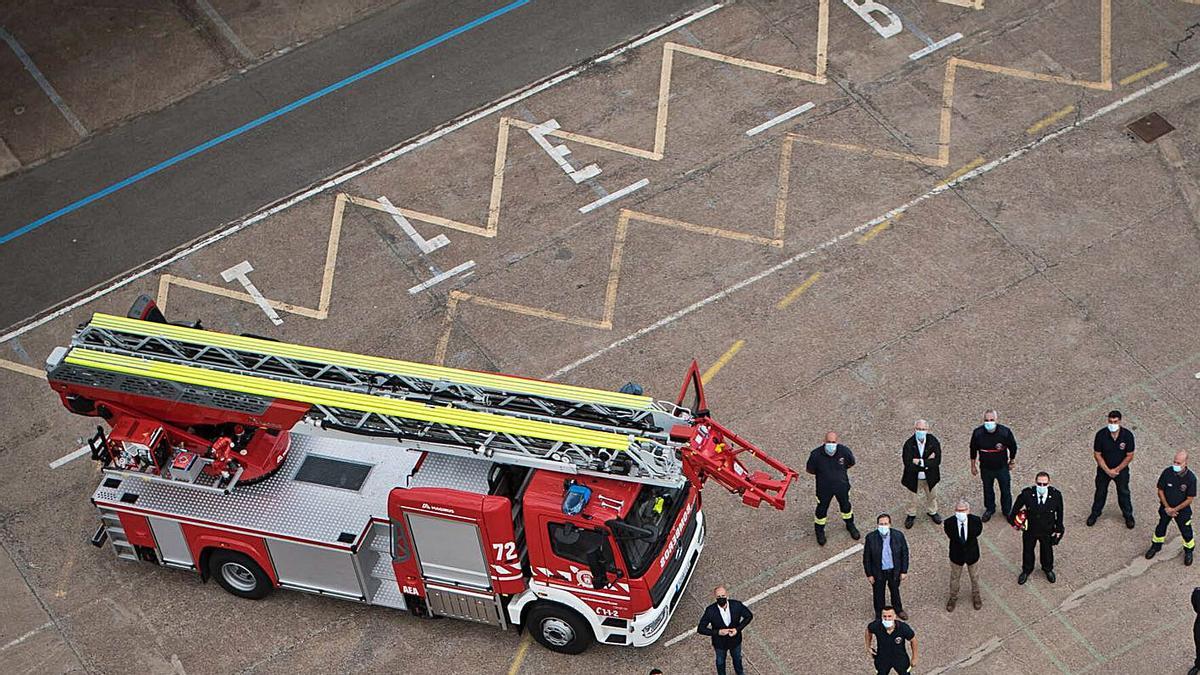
47;297;797;653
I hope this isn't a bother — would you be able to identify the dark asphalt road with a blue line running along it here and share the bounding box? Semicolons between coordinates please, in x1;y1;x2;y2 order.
0;0;707;325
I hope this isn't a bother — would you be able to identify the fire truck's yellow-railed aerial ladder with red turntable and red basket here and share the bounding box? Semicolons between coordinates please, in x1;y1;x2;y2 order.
47;299;797;508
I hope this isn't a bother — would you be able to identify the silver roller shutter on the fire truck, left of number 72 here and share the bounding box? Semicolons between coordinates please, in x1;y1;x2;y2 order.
406;513;492;590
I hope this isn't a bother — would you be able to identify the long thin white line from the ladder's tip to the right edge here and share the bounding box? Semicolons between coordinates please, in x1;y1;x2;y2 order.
549;55;1200;380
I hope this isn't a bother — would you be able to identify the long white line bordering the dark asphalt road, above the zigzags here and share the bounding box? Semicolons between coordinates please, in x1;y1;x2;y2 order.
0;2;729;344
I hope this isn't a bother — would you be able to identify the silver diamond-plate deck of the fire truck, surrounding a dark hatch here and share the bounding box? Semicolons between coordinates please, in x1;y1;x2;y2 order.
92;428;422;548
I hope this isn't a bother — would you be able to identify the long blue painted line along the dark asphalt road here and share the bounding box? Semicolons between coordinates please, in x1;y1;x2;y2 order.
0;0;533;244
